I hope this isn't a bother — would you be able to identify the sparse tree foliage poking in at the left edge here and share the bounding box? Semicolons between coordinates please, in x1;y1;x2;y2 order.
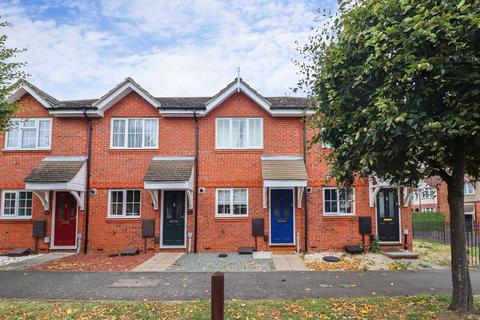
0;21;27;131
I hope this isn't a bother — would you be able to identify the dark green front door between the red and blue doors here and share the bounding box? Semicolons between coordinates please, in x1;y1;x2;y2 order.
162;191;185;246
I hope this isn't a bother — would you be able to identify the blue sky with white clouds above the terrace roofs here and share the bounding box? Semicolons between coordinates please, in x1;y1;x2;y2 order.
0;0;336;99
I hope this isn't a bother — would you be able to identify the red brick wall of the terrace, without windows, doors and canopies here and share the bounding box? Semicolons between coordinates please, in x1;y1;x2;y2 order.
0;93;411;252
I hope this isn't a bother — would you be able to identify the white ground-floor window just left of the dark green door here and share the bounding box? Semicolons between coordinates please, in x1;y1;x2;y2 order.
108;189;142;218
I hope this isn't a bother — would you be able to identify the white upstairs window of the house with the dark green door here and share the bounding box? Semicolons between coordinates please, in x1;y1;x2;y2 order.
110;118;158;149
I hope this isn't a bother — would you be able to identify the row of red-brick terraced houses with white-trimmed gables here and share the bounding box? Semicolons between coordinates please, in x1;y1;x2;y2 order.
0;78;411;252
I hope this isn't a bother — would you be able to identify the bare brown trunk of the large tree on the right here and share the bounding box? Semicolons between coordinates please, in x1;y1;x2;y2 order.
447;148;475;313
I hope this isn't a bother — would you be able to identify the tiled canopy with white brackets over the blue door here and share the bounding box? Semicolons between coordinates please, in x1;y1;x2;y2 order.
261;156;308;208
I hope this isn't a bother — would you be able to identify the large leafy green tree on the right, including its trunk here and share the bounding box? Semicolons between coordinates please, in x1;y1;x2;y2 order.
299;0;480;312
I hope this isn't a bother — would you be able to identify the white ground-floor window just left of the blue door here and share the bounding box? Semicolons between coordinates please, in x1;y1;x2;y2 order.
215;189;248;217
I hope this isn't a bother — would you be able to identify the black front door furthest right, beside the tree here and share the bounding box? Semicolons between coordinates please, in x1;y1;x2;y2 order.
377;189;400;242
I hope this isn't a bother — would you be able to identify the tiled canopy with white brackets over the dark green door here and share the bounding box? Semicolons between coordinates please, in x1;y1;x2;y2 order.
143;156;195;209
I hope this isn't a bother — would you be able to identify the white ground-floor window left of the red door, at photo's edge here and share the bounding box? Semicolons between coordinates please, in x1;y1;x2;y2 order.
1;190;33;219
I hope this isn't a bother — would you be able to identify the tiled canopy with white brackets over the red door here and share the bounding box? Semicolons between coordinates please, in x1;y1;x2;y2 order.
25;156;87;211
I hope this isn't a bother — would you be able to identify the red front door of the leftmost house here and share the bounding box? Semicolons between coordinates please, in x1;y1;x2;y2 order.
53;192;77;246
